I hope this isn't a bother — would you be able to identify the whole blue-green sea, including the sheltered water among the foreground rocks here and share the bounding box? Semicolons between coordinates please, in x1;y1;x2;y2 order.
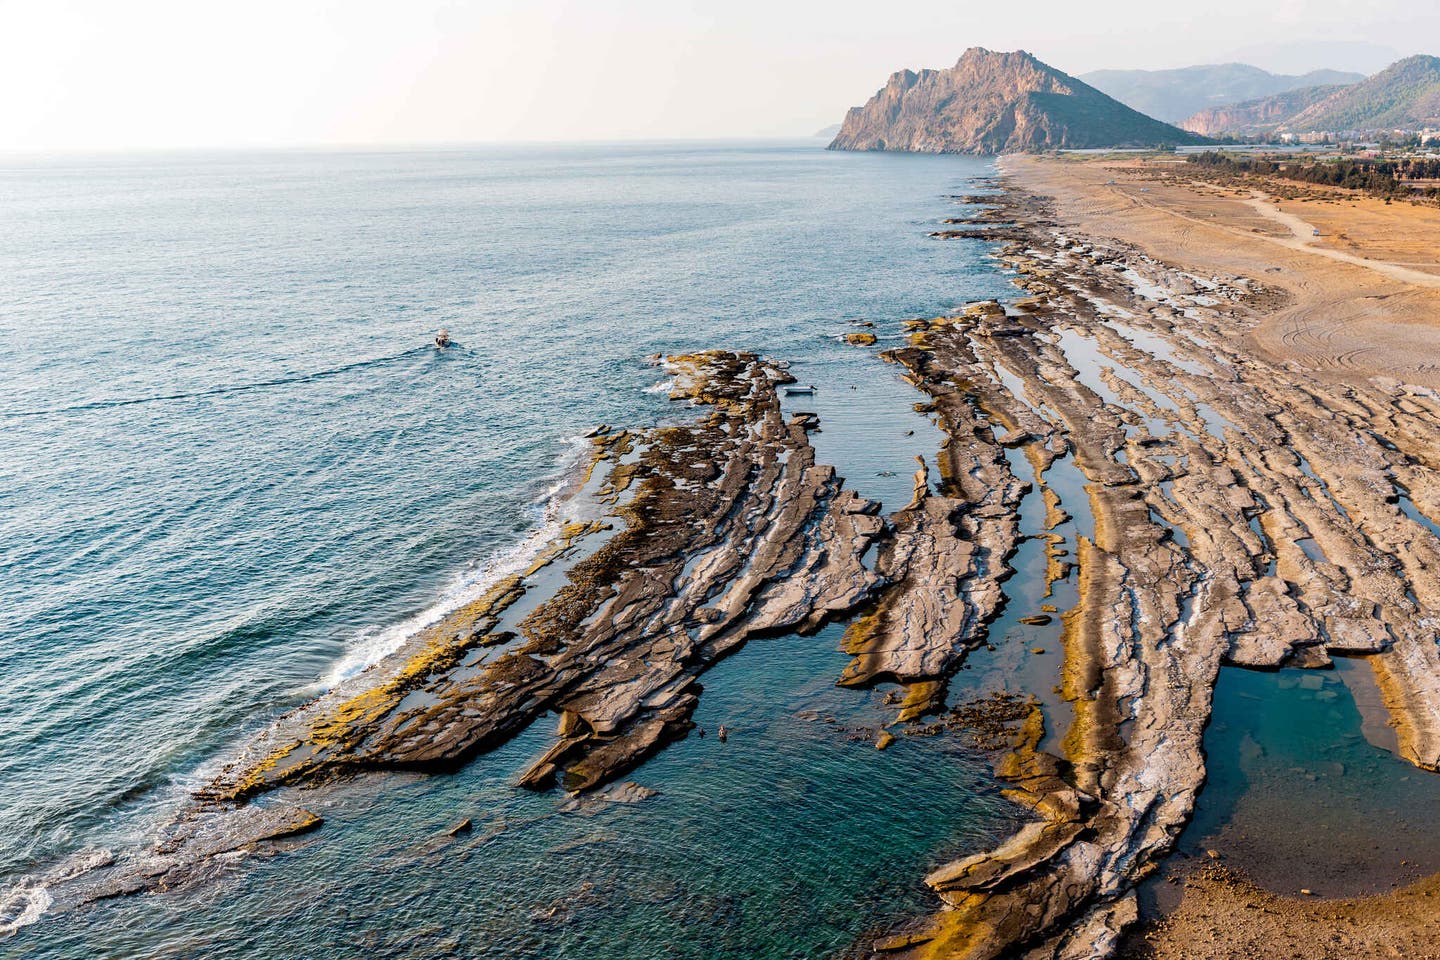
0;144;1014;959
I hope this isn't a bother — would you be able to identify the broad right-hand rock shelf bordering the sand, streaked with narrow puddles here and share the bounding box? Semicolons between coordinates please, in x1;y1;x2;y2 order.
858;182;1440;959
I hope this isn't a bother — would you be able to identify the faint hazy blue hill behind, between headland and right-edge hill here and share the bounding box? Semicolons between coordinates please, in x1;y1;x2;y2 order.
1080;63;1365;125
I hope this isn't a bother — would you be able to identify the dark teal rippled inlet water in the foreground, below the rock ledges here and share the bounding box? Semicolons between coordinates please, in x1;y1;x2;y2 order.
11;628;1017;960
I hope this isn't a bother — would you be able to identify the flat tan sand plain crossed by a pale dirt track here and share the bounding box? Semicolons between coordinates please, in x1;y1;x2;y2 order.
1002;157;1440;387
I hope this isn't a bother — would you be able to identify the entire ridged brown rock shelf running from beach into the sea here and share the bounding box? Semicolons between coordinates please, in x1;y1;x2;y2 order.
16;169;1440;959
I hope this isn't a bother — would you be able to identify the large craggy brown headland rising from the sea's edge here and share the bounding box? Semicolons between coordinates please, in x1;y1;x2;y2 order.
829;47;1204;154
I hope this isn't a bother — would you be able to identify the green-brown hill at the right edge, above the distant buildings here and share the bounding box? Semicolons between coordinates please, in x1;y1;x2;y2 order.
1181;56;1440;135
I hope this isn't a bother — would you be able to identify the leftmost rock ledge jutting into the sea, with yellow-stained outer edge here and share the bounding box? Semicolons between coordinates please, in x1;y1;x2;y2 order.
45;351;886;902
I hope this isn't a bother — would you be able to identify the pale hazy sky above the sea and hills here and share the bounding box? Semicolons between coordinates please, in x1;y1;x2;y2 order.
0;0;1440;151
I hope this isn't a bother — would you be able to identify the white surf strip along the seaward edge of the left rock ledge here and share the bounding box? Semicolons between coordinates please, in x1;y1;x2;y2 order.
307;438;590;692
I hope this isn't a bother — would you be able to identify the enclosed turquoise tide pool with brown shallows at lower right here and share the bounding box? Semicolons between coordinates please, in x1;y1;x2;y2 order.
1149;659;1440;904
